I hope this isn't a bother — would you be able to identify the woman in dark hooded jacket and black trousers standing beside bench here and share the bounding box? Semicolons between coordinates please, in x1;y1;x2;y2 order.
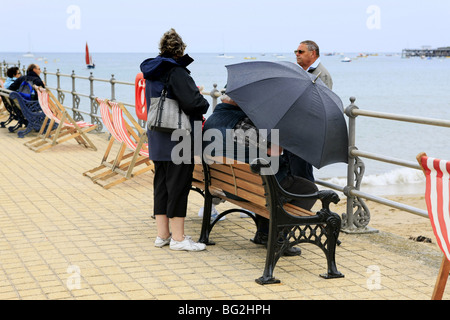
141;29;209;251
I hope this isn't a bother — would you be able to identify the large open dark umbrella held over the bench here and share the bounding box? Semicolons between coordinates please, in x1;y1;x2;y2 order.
226;61;348;169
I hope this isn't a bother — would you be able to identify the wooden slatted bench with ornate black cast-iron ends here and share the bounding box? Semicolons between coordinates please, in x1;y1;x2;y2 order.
192;159;344;284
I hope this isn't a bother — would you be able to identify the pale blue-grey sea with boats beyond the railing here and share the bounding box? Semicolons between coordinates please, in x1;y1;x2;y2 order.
0;52;450;196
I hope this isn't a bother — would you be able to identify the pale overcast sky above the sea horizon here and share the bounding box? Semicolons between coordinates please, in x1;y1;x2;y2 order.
0;0;450;53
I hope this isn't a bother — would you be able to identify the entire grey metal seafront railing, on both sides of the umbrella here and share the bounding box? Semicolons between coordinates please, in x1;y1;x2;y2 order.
0;61;450;233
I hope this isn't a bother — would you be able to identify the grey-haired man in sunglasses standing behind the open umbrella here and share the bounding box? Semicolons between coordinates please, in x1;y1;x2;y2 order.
294;40;333;90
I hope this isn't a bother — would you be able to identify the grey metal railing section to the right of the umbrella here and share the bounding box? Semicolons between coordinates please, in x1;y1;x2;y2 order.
317;97;450;233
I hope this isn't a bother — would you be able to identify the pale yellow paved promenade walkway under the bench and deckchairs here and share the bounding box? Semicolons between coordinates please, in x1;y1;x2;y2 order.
0;117;450;300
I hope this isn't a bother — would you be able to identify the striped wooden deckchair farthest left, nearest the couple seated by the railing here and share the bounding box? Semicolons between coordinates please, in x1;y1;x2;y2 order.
25;87;97;152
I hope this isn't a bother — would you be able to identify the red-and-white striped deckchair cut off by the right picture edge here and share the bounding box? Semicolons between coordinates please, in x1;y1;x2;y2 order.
417;152;450;300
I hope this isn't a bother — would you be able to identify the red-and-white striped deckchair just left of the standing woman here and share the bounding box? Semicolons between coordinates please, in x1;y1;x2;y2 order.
83;98;153;189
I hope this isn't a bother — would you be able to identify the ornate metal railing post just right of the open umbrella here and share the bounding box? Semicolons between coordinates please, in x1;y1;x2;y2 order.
342;97;377;233
